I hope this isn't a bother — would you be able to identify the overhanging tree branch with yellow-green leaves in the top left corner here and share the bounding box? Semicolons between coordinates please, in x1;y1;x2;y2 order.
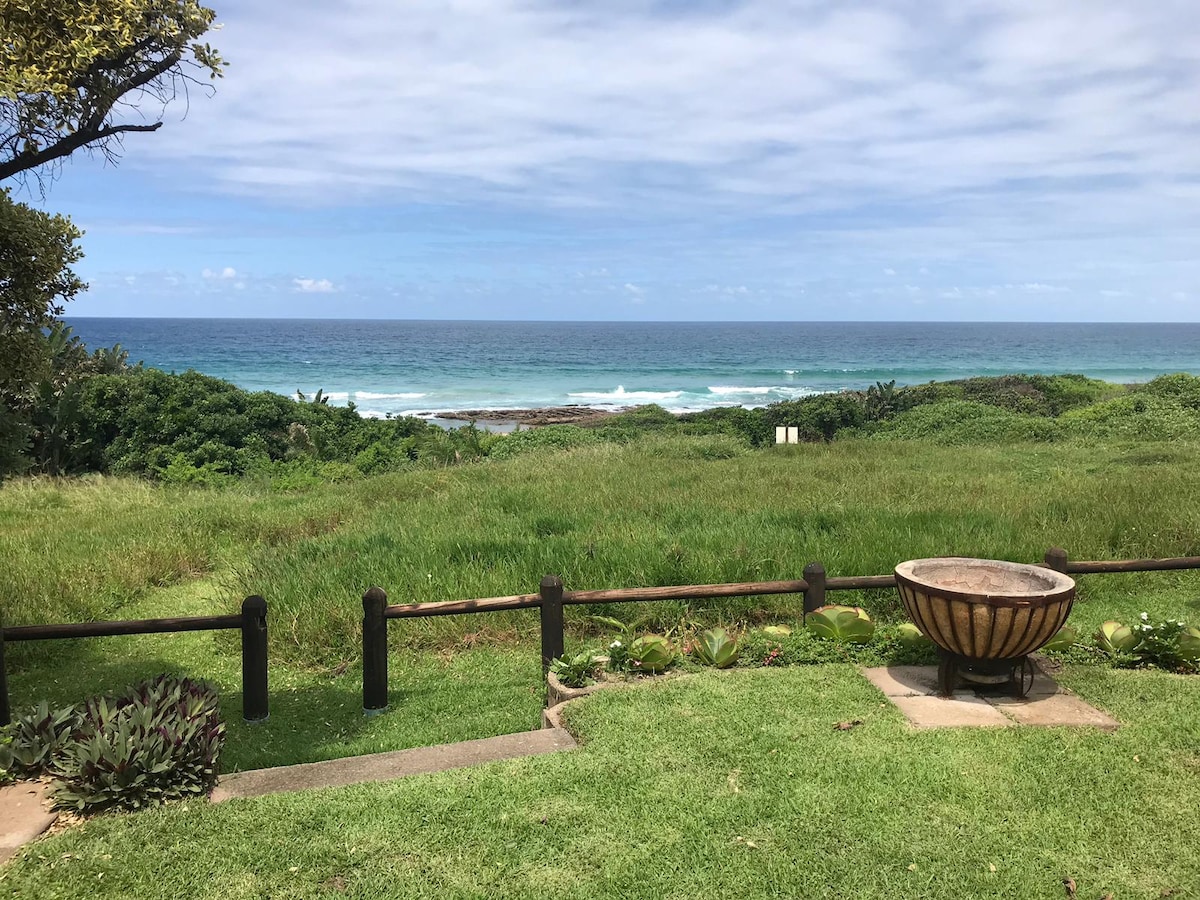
0;0;226;180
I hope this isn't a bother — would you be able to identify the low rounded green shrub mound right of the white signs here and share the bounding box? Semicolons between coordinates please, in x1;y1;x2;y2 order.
869;400;1058;444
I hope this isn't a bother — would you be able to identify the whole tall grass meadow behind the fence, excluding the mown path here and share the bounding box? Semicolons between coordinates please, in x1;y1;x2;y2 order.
0;434;1200;666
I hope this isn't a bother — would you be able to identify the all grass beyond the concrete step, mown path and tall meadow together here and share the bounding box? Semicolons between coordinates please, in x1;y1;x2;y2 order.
0;437;1200;769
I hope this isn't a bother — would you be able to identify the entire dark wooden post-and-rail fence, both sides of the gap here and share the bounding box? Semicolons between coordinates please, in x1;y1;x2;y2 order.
0;547;1200;725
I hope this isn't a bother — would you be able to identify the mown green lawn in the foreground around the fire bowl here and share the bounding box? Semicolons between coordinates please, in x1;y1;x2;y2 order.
0;666;1200;900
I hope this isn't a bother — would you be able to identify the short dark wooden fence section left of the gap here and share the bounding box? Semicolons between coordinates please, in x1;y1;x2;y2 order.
0;596;269;725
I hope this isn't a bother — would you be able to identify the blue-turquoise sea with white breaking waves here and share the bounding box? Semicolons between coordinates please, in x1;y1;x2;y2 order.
67;318;1200;416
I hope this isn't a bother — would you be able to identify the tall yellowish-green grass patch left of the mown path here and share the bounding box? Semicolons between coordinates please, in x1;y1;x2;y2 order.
0;476;352;625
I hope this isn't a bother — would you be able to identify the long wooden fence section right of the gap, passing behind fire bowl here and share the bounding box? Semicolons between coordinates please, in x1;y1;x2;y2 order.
362;547;1200;715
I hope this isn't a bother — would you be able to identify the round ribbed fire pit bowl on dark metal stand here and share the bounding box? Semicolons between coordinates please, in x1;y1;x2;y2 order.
896;557;1075;696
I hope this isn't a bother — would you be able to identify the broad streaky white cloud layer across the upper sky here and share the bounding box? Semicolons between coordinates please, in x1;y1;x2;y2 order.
126;0;1200;222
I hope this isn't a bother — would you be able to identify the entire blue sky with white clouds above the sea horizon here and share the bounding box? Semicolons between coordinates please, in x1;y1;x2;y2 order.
22;0;1200;322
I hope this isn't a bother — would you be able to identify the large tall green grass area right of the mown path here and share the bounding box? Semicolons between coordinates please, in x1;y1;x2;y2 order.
229;437;1200;664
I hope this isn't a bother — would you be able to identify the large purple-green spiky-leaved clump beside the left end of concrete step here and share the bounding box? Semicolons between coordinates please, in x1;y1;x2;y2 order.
53;676;224;810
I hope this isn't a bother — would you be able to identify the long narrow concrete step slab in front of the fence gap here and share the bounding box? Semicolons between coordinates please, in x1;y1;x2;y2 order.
211;728;577;803
